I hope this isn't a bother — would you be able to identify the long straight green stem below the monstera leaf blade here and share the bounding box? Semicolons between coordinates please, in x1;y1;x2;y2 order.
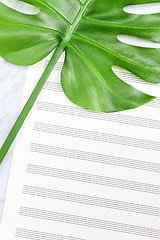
0;41;66;164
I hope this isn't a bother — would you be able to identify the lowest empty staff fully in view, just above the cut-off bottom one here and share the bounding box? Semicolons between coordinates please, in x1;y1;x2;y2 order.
19;206;160;239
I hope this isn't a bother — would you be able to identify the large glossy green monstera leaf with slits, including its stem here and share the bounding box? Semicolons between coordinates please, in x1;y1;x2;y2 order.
0;0;160;161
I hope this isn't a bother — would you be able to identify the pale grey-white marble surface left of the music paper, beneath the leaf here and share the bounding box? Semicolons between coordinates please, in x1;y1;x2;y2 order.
0;58;27;219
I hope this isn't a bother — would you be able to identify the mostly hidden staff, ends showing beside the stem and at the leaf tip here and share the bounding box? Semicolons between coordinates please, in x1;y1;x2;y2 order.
40;82;160;108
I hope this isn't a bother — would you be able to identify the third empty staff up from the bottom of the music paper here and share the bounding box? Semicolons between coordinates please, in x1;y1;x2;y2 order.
23;185;160;217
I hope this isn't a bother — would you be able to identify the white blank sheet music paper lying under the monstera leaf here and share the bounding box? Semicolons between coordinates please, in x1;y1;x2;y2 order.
0;47;160;240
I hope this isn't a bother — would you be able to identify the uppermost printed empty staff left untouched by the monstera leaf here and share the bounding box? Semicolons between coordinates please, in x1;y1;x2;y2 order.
33;122;160;151
